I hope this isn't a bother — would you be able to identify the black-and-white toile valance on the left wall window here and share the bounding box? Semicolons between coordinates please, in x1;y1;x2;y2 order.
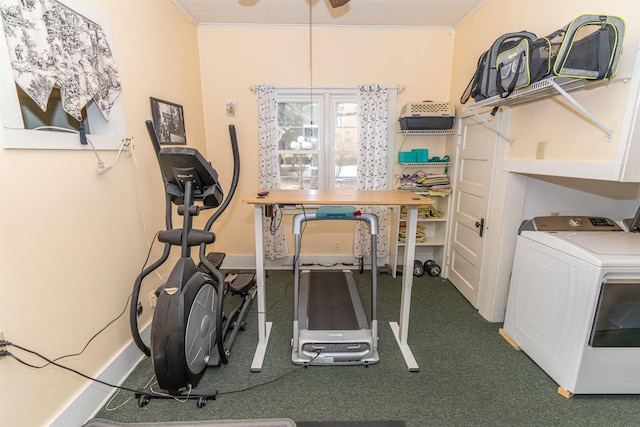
0;0;120;121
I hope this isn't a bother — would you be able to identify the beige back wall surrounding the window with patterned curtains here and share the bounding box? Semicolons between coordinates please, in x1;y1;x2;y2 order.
198;26;453;255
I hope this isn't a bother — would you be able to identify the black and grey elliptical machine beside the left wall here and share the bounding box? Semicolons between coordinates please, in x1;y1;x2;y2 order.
129;121;256;408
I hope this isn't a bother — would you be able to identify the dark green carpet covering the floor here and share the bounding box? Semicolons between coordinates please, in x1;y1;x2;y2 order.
96;271;640;427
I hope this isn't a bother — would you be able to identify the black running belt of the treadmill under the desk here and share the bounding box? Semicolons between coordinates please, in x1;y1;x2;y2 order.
308;271;360;330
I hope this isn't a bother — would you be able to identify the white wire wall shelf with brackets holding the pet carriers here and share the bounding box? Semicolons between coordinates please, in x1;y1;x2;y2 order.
464;77;630;143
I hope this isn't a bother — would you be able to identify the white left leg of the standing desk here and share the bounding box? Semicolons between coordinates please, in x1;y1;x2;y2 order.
251;205;271;372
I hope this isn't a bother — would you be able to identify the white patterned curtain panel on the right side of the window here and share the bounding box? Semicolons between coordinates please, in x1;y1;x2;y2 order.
354;84;389;260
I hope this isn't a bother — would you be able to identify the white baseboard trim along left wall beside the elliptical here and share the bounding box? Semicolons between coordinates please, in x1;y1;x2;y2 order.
48;324;151;427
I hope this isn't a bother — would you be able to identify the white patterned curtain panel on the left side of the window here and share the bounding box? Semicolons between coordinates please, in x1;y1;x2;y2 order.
255;84;287;260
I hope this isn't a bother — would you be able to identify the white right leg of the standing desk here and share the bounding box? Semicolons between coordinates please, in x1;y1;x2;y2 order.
389;206;420;372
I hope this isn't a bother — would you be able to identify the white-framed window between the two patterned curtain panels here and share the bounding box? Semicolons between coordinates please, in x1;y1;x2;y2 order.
278;89;358;190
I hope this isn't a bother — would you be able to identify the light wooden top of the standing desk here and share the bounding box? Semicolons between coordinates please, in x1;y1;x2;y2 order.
242;190;434;205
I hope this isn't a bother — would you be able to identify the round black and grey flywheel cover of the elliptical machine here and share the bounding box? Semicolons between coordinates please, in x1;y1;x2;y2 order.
151;265;221;393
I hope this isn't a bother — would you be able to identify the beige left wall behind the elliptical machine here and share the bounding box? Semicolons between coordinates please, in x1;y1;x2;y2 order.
0;0;205;426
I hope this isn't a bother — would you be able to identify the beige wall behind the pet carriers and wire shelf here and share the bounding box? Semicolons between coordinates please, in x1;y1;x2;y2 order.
451;0;640;166
